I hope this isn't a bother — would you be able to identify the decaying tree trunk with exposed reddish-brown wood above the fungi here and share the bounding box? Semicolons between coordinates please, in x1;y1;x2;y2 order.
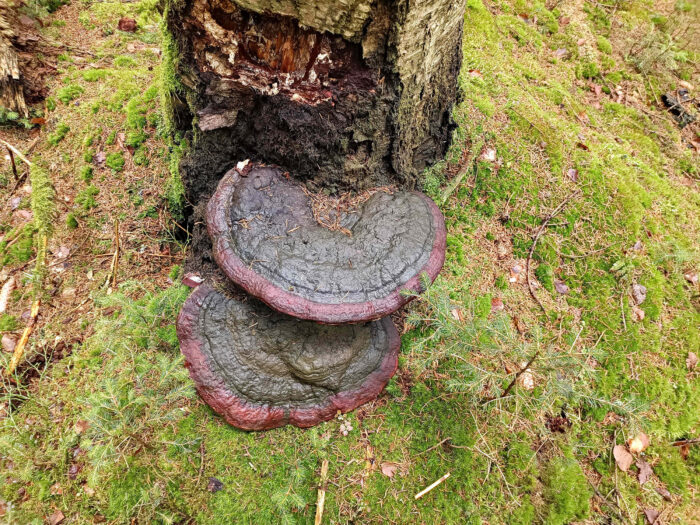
166;0;465;196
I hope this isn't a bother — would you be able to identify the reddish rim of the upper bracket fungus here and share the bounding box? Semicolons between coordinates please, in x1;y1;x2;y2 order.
207;167;447;324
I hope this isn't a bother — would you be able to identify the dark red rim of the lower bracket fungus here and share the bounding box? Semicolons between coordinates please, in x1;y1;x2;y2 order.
177;284;401;430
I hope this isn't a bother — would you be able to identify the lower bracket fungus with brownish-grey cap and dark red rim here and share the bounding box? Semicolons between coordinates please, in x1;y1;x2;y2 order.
177;284;400;430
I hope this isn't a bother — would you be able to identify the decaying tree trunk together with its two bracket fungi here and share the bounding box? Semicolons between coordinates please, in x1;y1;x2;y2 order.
172;0;466;428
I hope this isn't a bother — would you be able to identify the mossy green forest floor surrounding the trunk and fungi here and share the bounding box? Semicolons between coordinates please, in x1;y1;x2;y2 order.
0;0;700;525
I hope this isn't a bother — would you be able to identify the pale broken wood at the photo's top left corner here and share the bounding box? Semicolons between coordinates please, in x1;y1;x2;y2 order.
0;0;29;118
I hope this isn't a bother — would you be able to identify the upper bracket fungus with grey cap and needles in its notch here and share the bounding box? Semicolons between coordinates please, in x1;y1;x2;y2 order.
207;165;446;324
